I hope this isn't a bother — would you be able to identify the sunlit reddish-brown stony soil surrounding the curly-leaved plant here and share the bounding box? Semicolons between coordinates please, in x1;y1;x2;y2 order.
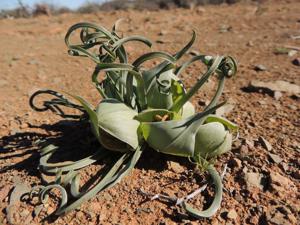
0;1;300;225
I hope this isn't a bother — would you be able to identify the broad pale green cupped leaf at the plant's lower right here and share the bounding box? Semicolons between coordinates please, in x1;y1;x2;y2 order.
141;102;231;157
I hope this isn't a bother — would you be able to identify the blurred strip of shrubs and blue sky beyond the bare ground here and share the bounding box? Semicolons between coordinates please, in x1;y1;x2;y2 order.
0;0;251;18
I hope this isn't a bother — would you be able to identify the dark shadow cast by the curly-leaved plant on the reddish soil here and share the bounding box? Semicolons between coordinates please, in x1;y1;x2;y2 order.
0;120;210;223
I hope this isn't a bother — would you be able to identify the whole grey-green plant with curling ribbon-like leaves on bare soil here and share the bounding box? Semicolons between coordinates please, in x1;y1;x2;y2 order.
30;22;237;218
